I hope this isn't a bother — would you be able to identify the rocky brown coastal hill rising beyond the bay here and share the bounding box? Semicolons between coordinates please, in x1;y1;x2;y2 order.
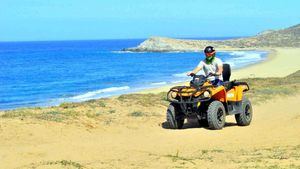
124;24;300;52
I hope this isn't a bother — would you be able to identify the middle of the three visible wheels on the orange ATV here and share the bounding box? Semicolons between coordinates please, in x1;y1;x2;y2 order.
207;101;226;130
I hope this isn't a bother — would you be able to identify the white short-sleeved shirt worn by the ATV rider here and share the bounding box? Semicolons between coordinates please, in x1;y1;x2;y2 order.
197;57;223;81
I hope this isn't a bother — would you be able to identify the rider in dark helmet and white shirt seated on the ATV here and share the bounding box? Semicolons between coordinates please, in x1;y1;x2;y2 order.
187;46;223;86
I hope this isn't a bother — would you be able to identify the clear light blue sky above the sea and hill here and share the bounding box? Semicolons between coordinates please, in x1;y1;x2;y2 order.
0;0;300;41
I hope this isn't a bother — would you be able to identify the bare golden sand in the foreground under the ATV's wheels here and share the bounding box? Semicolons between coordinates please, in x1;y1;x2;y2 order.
0;95;300;168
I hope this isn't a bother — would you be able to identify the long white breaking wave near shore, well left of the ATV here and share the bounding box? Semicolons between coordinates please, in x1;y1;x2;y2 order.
69;86;130;101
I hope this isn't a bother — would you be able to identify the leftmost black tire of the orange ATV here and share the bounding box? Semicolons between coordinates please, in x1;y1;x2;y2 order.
167;103;184;129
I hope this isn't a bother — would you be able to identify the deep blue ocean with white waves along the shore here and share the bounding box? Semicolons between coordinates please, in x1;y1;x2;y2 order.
0;39;267;110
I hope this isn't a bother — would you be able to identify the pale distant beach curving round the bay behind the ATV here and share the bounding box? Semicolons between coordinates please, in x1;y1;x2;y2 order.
138;48;300;93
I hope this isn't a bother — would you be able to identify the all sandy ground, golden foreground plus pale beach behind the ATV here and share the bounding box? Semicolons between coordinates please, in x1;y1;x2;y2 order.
0;48;300;169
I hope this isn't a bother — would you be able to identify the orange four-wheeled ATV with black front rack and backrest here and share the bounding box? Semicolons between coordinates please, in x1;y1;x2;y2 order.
167;64;252;130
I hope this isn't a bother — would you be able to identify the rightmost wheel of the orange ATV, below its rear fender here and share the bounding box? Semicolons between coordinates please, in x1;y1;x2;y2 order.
235;97;253;126
